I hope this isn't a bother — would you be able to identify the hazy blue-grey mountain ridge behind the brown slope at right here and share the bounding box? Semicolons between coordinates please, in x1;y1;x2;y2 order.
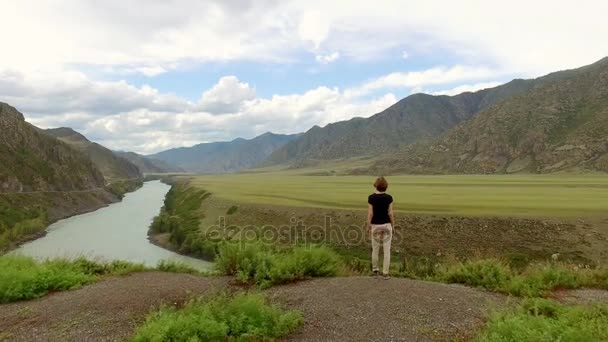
266;69;580;165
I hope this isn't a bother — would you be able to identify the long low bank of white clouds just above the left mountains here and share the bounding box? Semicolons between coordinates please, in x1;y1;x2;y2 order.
0;72;404;153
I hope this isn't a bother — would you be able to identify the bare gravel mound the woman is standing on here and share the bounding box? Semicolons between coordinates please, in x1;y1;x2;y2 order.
267;277;506;341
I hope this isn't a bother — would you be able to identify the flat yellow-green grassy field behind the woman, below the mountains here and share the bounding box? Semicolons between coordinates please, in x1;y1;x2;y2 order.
192;171;608;217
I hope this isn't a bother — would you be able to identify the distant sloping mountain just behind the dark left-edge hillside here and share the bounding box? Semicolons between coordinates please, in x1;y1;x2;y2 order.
44;127;142;180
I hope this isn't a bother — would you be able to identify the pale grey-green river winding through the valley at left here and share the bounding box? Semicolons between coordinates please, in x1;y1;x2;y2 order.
14;181;212;270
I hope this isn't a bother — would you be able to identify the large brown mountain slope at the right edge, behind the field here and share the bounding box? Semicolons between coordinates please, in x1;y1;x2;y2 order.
372;58;608;173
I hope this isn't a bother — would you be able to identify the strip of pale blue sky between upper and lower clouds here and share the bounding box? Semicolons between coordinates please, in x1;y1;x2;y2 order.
120;49;498;101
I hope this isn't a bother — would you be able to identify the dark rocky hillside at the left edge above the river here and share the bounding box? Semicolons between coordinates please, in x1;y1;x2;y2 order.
0;102;105;193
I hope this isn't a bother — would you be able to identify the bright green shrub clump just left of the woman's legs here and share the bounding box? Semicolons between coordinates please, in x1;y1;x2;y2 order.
215;242;342;288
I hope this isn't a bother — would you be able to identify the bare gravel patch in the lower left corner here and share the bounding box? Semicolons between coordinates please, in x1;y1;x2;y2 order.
0;272;230;341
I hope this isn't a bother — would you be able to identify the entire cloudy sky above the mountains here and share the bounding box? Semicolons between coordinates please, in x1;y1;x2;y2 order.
0;0;608;153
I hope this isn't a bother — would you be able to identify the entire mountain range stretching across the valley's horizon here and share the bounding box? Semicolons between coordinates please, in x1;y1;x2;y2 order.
0;58;608;180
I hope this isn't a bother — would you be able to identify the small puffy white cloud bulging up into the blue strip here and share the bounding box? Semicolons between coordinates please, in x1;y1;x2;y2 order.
199;76;255;114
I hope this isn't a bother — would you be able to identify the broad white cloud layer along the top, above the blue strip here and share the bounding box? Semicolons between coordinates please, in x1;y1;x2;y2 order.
0;0;608;76
